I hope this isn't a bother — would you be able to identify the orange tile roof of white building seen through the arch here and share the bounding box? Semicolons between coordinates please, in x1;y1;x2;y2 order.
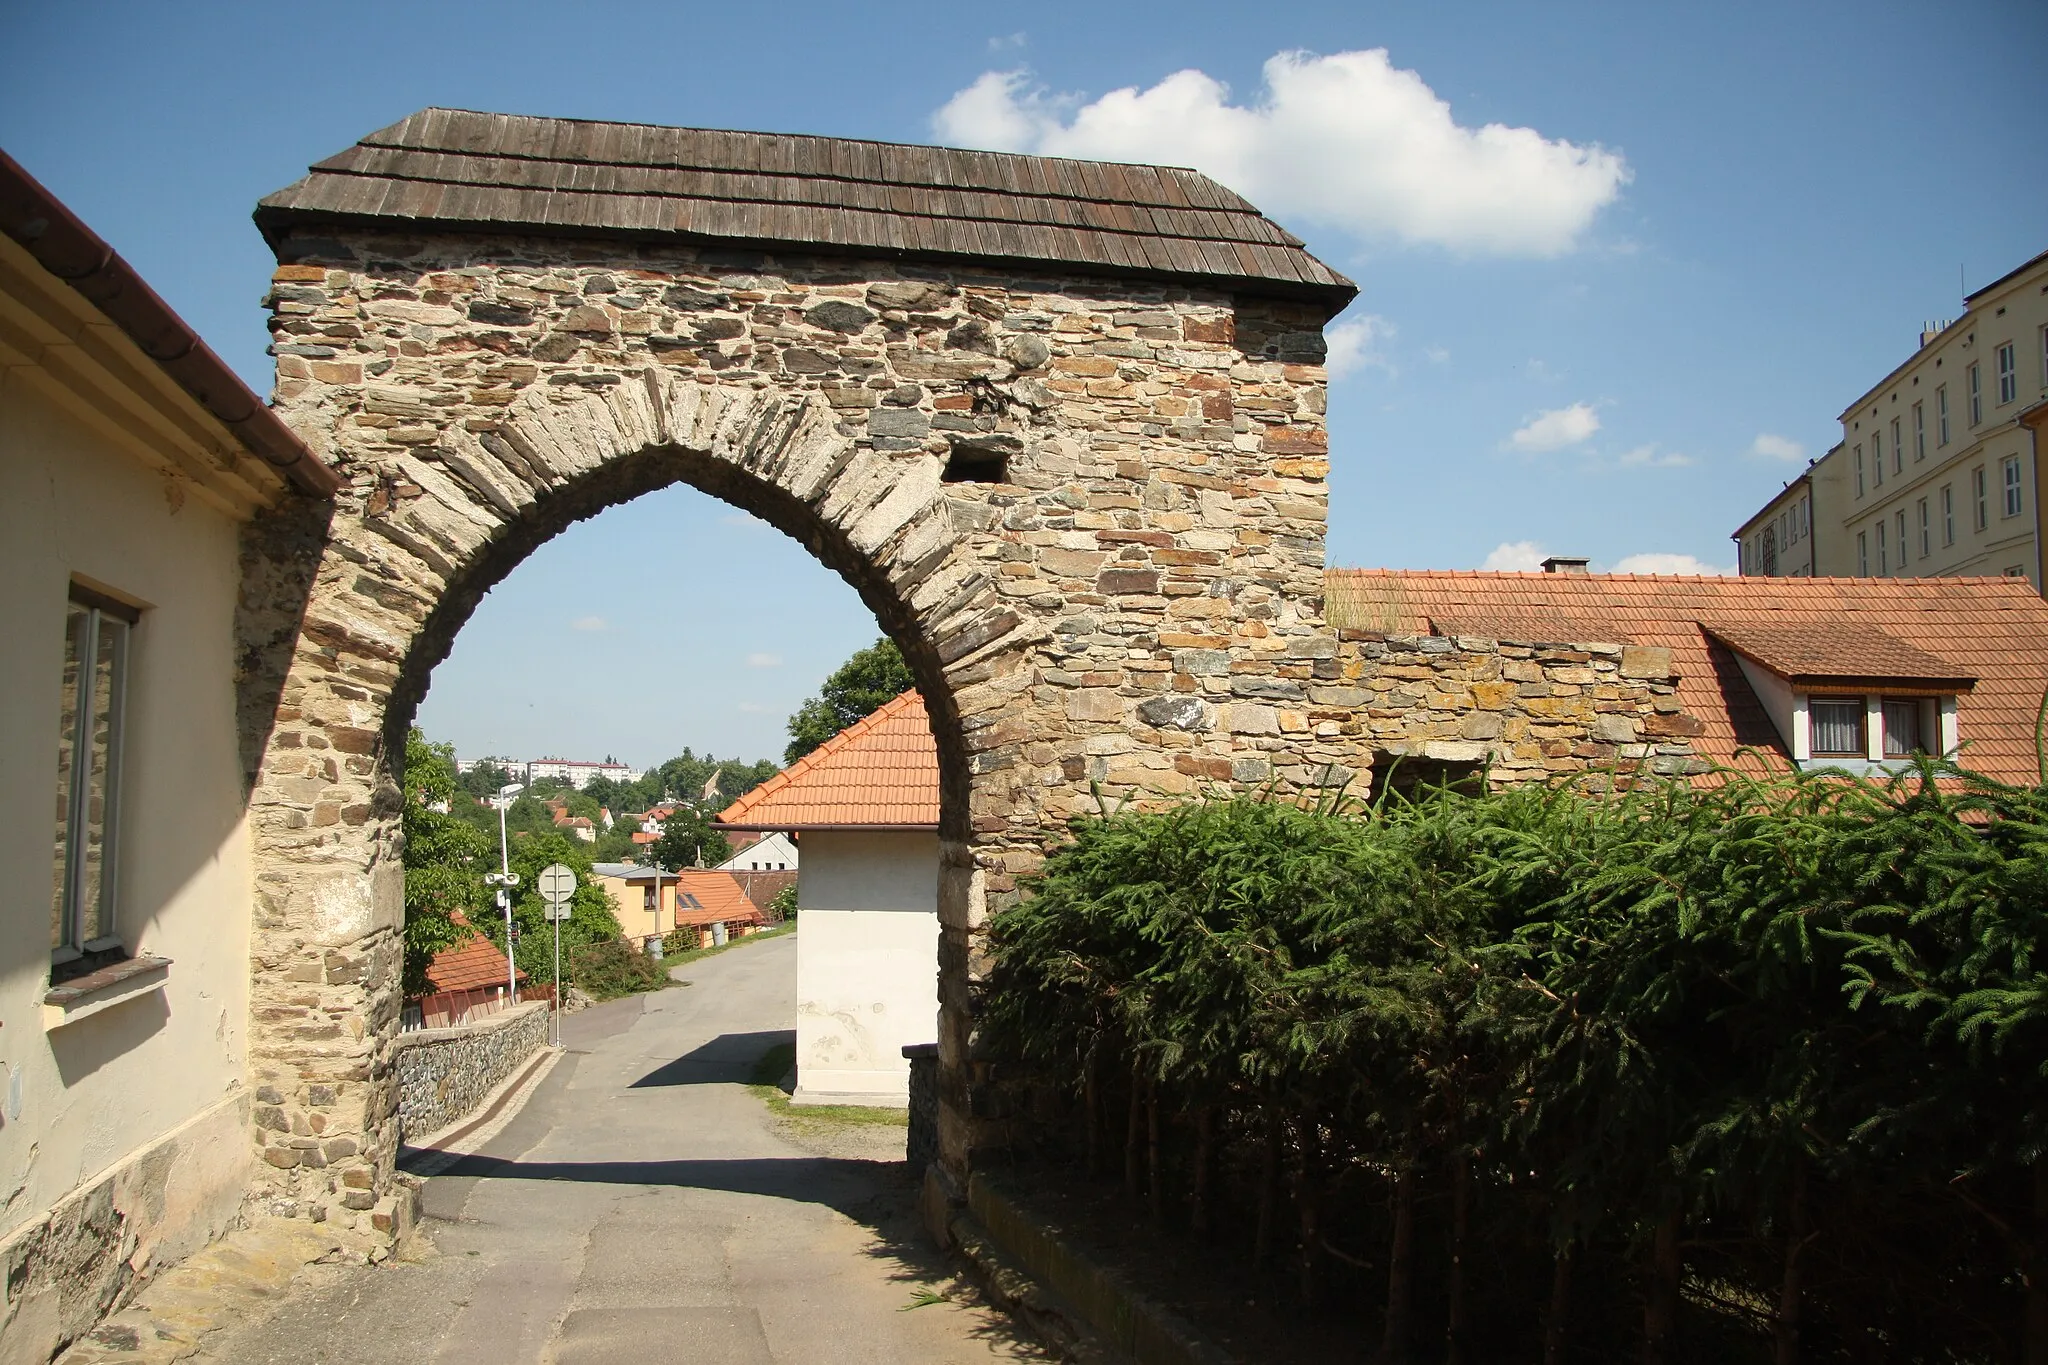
717;692;938;829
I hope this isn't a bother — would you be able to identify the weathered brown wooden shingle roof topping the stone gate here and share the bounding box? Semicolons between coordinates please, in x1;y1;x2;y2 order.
256;108;1358;313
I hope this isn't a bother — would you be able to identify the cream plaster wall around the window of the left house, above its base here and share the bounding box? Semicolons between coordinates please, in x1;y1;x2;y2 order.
0;370;252;1240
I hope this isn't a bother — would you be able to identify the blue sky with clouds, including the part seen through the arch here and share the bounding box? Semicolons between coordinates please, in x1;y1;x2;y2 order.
0;0;2048;761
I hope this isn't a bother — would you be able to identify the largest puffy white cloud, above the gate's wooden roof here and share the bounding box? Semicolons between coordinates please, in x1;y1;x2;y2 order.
932;47;1630;256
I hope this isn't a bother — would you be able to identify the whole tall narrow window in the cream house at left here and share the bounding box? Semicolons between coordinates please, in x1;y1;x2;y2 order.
49;585;137;964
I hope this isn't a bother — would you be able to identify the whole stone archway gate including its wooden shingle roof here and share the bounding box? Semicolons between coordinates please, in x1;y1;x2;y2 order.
242;111;1356;1212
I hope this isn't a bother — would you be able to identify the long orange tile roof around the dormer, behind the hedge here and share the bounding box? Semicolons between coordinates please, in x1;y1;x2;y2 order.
1325;569;2048;782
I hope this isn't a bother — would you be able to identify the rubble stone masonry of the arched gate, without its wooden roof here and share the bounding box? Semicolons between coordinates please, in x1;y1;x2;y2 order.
244;233;1356;1205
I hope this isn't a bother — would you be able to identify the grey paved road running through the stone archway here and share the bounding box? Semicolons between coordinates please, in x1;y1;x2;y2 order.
199;935;1051;1365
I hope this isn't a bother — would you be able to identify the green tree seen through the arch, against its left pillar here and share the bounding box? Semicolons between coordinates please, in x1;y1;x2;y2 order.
403;729;494;997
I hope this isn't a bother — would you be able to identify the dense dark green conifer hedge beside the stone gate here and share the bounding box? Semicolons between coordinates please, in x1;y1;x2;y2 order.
979;763;2048;1361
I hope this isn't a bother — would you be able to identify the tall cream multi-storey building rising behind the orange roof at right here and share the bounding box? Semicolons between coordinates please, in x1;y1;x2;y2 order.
1735;252;2048;589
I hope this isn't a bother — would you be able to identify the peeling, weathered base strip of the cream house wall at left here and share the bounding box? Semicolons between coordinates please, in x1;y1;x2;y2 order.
0;1091;250;1361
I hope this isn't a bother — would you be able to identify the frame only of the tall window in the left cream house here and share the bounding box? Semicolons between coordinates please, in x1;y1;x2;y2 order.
49;583;141;980
